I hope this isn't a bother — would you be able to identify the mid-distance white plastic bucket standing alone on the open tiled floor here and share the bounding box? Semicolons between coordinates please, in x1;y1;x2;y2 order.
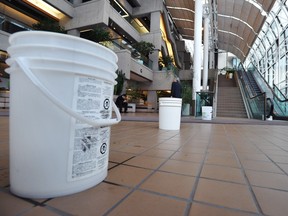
159;97;182;130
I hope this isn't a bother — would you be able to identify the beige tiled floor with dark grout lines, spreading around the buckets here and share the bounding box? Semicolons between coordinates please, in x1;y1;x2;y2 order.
0;117;288;216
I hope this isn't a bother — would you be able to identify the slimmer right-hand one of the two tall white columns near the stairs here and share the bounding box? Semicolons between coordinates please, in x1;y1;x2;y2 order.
203;15;209;91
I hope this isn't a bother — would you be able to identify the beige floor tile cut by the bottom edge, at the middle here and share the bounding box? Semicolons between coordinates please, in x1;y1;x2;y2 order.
109;191;186;216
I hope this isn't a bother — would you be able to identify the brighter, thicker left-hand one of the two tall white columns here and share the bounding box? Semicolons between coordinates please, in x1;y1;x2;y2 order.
192;0;202;114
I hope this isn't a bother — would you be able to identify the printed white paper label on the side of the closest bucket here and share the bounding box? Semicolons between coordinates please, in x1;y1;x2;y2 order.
68;76;114;181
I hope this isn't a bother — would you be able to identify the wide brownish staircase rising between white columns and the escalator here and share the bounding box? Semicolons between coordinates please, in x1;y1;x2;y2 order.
217;75;247;118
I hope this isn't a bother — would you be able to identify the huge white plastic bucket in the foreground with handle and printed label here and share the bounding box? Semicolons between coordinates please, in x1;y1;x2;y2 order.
7;31;121;198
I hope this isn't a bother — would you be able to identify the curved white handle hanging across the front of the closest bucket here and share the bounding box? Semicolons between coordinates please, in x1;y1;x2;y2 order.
15;57;121;127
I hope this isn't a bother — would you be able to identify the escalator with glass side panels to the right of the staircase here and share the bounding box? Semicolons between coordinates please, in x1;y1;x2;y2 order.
238;64;288;120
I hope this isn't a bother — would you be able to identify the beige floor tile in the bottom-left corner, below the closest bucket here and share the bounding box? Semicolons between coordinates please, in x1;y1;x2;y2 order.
0;191;33;216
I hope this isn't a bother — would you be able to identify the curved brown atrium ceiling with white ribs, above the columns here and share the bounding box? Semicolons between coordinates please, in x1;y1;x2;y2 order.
165;0;276;62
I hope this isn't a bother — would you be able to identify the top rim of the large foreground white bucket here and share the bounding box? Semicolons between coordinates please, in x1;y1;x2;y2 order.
8;30;117;60
